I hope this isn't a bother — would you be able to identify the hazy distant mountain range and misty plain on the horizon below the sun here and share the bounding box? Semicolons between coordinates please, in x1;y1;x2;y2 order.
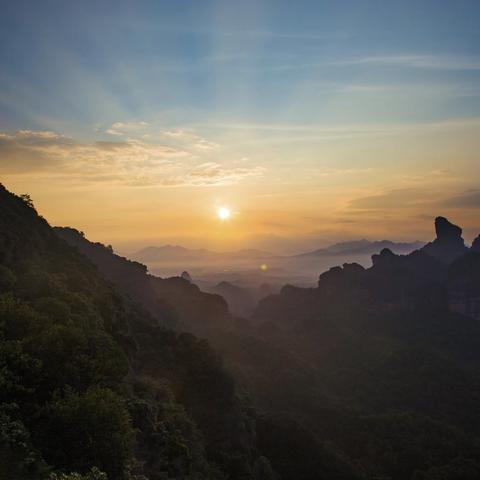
132;240;423;294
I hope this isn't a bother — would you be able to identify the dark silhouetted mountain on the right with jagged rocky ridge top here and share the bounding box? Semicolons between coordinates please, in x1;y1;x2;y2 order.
248;217;480;480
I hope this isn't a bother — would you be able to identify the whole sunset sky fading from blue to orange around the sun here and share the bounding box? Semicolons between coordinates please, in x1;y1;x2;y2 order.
0;0;480;253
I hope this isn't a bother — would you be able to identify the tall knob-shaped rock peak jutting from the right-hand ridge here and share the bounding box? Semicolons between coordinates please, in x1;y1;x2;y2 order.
422;217;469;264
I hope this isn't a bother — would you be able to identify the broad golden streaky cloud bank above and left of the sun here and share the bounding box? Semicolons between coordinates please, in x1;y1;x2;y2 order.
0;130;264;186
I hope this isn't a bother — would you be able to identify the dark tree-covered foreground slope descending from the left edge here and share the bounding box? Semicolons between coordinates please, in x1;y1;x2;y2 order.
0;186;273;480
